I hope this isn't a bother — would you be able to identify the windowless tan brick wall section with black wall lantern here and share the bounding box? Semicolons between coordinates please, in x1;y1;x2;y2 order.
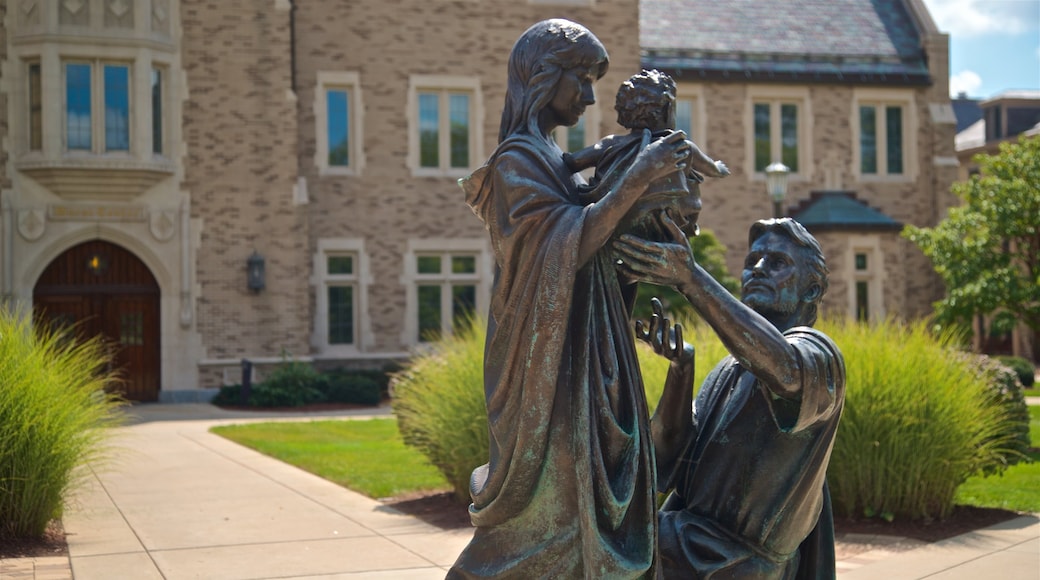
181;0;310;360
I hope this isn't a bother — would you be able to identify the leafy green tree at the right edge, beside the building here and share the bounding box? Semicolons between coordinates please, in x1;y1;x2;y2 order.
904;136;1040;340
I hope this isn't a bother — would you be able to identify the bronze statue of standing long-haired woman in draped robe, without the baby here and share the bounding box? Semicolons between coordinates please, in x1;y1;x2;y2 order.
448;20;691;578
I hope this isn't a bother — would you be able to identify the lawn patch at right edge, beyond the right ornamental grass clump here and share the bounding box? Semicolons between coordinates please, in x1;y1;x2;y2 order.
957;405;1040;512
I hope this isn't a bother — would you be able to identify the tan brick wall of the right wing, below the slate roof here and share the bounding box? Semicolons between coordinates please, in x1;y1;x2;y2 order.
679;78;956;317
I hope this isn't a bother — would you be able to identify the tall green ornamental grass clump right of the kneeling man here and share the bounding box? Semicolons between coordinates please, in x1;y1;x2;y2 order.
821;320;1013;520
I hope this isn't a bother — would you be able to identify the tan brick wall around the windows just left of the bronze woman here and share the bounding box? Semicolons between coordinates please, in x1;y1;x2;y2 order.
296;0;639;352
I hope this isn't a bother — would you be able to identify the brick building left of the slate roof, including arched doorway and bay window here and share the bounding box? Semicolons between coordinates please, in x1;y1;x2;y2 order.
0;0;639;400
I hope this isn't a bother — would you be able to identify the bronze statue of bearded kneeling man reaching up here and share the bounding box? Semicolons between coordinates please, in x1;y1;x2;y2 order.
615;215;846;579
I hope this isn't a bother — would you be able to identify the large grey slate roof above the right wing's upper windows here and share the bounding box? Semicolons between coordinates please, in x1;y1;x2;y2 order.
640;0;931;85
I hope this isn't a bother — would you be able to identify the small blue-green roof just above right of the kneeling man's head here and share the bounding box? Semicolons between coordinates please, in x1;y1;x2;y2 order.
791;191;903;232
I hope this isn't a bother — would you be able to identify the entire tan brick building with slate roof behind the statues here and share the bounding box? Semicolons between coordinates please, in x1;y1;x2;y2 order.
0;0;956;401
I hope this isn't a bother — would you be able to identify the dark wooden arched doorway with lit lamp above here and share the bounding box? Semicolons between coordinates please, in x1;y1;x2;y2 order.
32;240;160;401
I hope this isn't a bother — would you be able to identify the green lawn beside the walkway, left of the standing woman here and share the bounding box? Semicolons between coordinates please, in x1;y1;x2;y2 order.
212;419;450;499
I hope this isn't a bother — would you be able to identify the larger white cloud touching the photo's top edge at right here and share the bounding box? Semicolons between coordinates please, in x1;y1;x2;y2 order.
924;0;1040;36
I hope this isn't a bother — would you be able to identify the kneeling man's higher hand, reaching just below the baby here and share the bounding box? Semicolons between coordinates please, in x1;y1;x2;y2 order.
614;212;697;288
